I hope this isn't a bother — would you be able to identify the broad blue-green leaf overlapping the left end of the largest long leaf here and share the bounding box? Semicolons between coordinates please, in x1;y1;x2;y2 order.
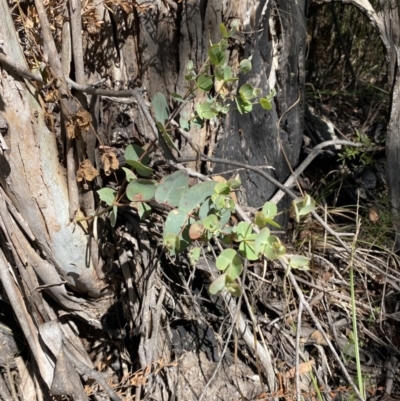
155;170;189;207
